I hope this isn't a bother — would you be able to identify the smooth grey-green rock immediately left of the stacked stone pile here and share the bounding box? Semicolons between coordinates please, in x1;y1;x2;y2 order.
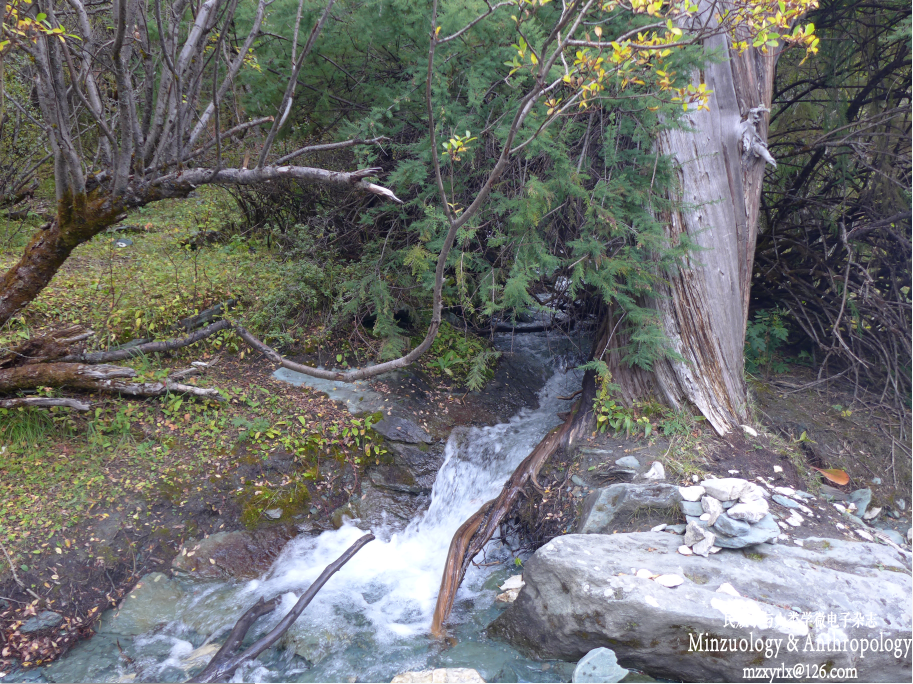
577;483;681;534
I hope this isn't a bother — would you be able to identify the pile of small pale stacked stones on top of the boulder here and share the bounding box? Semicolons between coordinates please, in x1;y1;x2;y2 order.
678;477;780;557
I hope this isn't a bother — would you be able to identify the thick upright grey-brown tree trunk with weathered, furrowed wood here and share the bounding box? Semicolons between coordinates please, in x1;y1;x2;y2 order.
606;24;779;434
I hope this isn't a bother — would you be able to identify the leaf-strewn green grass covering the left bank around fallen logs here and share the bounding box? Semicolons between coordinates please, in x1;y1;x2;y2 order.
0;187;382;565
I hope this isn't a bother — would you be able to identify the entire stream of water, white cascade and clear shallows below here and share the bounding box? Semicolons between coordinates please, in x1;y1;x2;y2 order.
35;335;580;682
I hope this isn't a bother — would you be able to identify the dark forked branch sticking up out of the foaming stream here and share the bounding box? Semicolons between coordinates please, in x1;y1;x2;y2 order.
192;534;374;684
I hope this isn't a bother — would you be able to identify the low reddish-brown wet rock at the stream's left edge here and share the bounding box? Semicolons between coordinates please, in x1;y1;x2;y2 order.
171;525;295;579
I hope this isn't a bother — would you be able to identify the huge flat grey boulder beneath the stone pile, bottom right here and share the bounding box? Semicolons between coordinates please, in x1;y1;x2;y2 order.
489;532;913;681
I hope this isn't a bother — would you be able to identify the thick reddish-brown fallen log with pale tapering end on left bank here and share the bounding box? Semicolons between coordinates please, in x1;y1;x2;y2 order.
0;363;222;401
